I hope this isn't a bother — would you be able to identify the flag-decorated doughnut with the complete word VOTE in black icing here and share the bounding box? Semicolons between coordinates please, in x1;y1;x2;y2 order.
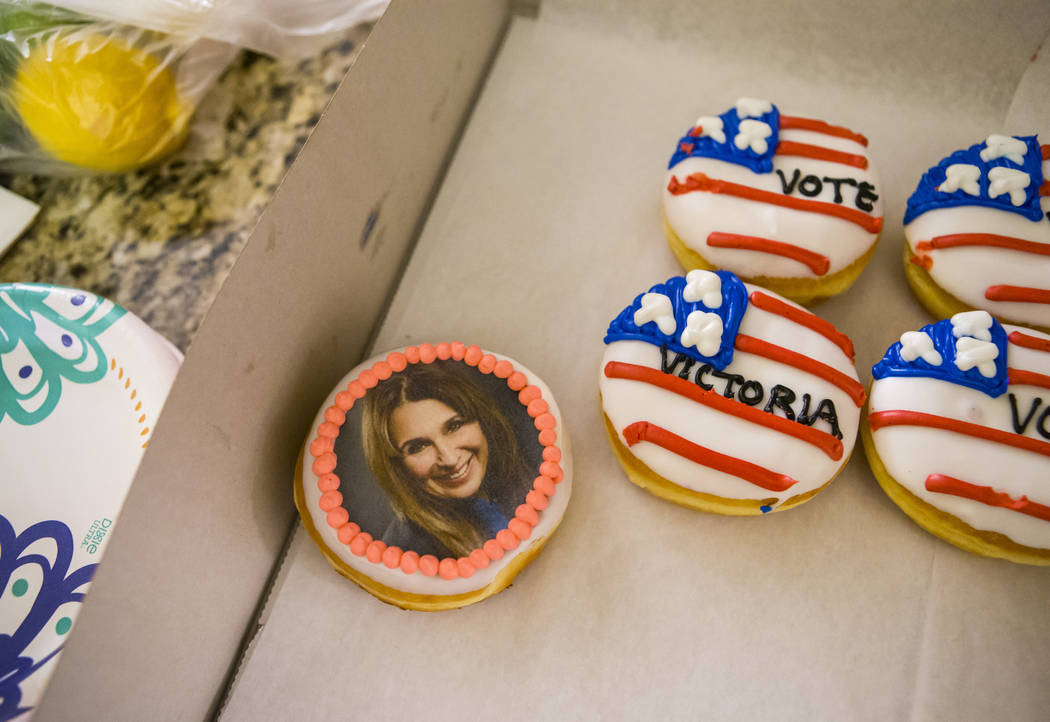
664;98;882;304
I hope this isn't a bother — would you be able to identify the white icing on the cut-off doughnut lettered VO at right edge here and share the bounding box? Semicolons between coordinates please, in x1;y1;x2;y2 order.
868;325;1050;549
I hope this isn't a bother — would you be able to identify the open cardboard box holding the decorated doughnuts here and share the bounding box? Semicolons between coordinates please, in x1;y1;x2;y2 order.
39;0;1050;720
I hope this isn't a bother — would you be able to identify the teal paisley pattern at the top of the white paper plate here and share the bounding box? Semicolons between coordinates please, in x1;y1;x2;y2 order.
0;283;126;426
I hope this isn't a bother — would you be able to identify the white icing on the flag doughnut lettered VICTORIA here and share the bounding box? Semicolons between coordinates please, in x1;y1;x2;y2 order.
600;285;860;504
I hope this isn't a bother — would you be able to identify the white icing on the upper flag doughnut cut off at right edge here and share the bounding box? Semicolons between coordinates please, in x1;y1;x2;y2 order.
904;198;1050;326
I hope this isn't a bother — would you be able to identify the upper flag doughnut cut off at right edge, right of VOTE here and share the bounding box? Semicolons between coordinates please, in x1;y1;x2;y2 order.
904;134;1050;332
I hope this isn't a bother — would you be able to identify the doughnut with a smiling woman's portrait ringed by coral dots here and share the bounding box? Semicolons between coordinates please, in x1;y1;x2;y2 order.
294;341;572;611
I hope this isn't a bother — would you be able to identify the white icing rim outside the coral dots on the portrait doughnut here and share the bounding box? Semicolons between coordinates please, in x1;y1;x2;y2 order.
301;348;572;596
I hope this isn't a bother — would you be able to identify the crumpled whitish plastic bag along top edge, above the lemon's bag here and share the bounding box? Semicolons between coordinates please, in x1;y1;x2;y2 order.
49;0;390;59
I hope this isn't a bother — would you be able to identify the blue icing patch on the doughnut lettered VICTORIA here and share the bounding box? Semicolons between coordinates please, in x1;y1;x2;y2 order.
605;271;748;370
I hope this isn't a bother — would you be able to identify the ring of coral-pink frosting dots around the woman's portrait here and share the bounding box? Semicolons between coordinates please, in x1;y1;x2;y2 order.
309;341;565;579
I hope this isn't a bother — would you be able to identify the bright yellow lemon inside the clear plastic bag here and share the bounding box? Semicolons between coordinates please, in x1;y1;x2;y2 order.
13;33;192;171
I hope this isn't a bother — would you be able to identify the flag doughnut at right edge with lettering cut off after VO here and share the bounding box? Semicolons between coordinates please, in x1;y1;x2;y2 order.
863;311;1050;565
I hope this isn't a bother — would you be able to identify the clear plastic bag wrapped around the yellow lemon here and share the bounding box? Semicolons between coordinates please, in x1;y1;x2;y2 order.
0;0;237;174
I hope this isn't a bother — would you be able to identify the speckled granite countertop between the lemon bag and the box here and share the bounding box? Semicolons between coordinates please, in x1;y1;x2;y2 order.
0;26;371;352
